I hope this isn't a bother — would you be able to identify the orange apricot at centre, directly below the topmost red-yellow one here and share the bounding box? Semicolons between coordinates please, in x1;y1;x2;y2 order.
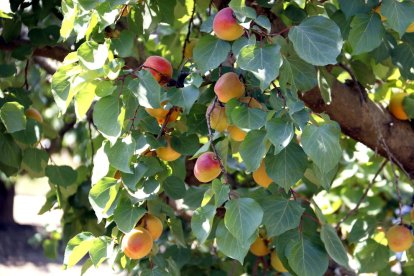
214;72;245;103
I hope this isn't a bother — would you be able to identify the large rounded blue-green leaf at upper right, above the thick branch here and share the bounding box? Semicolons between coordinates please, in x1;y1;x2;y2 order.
289;16;343;66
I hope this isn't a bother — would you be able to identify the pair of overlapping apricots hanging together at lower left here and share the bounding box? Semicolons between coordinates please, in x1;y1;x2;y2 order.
121;214;163;259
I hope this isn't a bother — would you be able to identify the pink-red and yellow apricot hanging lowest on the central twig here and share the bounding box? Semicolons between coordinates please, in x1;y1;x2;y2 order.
194;152;221;183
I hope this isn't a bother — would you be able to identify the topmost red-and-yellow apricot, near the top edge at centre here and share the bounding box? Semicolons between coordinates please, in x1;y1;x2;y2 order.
213;8;244;41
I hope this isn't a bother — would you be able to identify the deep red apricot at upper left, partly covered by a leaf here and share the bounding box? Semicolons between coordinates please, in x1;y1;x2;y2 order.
142;56;173;85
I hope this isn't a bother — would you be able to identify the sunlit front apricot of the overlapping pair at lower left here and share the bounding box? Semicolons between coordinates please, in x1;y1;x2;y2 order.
121;226;153;259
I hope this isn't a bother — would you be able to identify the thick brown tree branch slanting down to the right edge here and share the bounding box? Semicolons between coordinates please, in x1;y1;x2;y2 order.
301;82;414;178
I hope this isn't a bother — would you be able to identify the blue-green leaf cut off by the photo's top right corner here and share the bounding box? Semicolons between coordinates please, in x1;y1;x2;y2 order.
381;0;414;36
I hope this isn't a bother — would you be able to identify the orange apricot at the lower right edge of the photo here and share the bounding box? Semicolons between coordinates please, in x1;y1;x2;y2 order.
386;225;413;252
